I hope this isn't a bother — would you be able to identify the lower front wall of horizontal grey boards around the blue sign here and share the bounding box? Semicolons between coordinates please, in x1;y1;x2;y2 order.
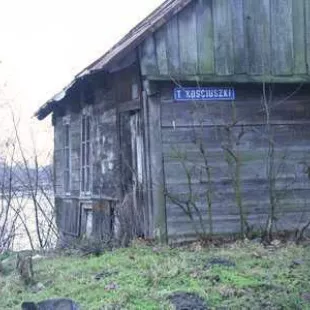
161;84;310;240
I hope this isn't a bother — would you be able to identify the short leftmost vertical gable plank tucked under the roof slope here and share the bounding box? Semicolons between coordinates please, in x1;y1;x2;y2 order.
140;35;159;75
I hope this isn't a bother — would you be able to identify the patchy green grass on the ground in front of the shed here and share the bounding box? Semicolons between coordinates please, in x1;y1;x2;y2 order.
0;242;310;310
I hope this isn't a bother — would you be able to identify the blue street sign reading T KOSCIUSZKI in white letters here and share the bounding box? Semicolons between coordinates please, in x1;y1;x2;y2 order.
174;87;236;101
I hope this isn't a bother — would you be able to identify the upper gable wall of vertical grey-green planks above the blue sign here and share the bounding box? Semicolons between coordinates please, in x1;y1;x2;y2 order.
140;0;310;82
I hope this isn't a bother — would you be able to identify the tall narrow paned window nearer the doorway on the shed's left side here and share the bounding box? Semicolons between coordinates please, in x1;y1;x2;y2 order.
81;114;91;194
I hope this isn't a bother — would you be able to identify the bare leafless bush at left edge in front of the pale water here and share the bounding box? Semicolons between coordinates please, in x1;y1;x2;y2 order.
0;114;57;253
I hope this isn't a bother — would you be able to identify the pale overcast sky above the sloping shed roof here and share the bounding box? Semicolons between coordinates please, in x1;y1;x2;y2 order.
0;0;163;163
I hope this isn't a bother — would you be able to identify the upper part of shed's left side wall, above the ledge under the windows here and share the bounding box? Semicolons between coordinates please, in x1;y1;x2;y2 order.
54;87;118;199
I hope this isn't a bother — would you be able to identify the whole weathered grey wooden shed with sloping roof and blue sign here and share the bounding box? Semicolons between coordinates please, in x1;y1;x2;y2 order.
36;0;310;242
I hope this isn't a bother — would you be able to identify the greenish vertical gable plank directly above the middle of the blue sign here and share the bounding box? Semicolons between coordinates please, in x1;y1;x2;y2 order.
196;0;214;74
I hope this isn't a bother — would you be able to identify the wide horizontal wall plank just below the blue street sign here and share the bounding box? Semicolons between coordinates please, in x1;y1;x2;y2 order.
162;97;310;127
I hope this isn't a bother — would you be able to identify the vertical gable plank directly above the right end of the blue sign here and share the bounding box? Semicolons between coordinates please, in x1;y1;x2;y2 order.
213;0;234;75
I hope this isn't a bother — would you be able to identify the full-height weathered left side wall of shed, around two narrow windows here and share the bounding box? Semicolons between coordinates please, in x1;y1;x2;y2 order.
54;83;119;238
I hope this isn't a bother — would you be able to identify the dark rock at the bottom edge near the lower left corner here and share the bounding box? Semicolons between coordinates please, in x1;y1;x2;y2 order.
21;298;80;310
